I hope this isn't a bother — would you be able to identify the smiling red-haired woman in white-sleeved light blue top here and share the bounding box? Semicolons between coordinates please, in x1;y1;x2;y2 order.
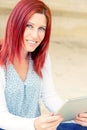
0;0;63;130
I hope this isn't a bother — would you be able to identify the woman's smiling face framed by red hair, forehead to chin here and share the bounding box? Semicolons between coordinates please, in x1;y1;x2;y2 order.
23;13;47;52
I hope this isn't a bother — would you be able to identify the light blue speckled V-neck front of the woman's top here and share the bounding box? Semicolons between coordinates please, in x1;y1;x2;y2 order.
5;60;41;118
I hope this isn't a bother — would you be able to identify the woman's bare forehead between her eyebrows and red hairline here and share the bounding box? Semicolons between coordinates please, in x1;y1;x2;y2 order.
28;13;47;26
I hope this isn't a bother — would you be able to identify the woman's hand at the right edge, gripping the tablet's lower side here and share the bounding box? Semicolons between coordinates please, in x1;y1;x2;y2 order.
74;112;87;126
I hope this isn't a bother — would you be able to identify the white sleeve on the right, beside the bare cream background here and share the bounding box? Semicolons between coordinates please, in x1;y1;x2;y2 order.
41;55;64;113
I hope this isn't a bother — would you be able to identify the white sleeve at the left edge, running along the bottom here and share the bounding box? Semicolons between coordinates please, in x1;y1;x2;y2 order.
0;67;35;130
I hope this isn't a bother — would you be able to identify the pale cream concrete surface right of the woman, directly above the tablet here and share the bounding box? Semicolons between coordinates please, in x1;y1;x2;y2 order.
41;41;87;113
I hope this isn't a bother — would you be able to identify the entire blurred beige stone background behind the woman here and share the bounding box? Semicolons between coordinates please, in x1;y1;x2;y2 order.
0;0;87;102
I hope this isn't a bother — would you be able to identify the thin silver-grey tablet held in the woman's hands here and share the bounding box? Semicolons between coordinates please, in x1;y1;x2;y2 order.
57;97;87;121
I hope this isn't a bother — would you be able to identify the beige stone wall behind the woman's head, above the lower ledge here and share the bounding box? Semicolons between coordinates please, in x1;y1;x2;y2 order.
0;0;87;45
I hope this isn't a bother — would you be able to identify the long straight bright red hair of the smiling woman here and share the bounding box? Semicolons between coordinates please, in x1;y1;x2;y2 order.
0;0;51;77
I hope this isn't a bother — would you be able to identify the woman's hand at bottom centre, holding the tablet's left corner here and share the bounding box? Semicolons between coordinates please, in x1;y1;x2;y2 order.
35;113;63;130
